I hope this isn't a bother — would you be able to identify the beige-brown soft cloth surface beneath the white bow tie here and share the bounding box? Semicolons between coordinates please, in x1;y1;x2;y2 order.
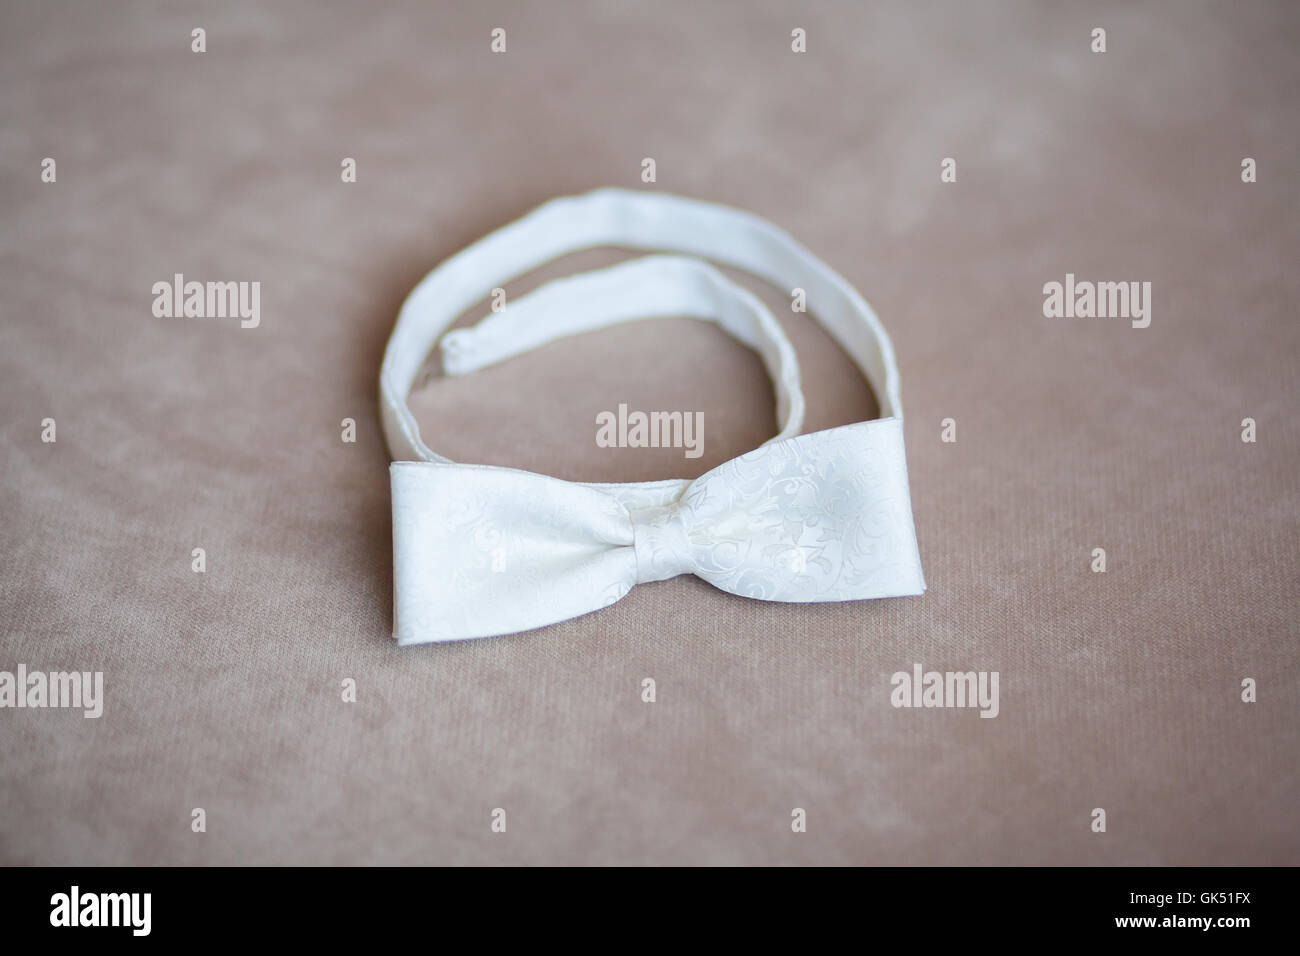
0;0;1300;864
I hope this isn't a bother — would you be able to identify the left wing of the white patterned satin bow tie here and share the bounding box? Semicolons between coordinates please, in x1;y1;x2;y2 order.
389;462;636;645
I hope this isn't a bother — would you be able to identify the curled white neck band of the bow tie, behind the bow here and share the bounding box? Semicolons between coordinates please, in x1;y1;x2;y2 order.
380;189;902;470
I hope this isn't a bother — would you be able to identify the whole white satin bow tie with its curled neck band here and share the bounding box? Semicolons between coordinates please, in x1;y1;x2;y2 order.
380;189;926;645
